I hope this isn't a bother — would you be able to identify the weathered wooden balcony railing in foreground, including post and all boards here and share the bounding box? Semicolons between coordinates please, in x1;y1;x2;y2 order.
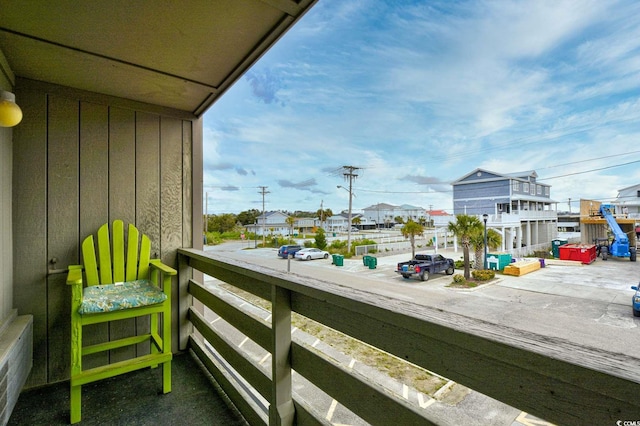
178;249;640;425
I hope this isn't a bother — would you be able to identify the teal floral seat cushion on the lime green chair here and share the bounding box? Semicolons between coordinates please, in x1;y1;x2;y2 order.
78;280;167;314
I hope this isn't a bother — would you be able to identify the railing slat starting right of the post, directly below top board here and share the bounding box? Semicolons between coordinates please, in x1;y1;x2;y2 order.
291;342;436;425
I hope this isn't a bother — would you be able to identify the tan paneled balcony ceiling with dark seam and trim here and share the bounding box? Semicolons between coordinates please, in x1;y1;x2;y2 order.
0;0;316;116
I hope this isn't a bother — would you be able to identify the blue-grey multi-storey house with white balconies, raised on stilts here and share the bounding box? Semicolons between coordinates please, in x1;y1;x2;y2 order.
452;169;558;250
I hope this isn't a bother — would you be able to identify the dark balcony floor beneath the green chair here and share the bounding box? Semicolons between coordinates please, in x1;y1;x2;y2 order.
8;353;247;426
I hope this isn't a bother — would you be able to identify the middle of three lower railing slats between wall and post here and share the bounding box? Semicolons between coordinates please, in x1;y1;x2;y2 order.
189;309;272;399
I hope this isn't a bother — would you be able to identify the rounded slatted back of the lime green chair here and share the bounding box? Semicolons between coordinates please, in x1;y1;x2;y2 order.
82;220;151;285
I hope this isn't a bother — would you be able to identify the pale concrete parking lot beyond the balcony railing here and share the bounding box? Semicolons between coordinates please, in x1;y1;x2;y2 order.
208;243;640;358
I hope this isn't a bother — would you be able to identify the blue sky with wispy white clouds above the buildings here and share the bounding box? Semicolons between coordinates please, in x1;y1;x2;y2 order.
204;0;640;214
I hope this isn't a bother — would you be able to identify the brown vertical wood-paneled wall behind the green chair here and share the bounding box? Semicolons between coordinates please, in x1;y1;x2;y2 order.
13;80;196;387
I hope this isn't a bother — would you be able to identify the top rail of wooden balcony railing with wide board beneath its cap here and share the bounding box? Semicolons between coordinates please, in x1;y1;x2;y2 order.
181;249;640;424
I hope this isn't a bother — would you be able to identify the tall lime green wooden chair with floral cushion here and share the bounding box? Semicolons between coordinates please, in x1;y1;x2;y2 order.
67;220;176;423
